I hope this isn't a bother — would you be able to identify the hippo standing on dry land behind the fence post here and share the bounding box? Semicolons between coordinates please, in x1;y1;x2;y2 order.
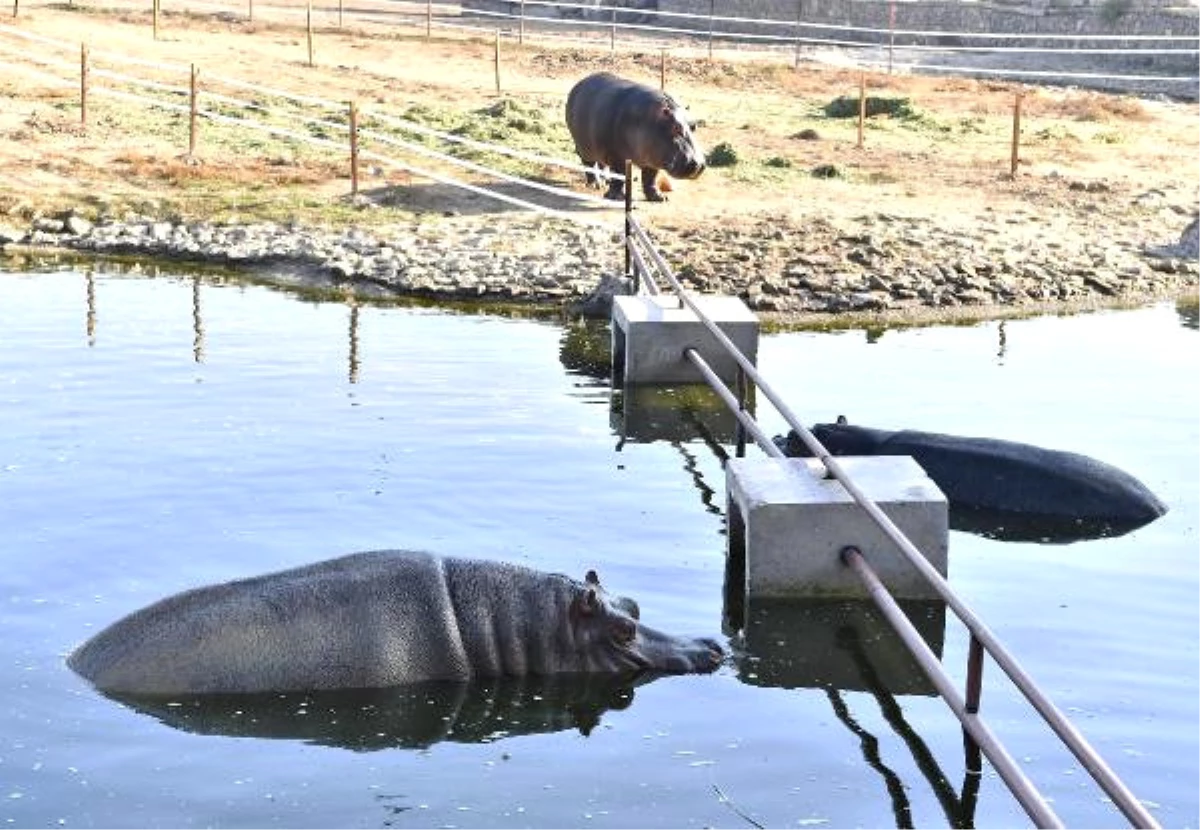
566;72;704;202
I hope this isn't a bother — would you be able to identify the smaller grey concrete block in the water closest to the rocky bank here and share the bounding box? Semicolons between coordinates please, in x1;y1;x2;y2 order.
612;295;758;386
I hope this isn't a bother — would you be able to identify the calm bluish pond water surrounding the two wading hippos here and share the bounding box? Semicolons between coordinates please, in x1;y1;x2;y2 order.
0;262;1200;828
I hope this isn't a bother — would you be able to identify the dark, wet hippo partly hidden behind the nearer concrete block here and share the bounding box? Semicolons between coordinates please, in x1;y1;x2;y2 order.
778;417;1166;541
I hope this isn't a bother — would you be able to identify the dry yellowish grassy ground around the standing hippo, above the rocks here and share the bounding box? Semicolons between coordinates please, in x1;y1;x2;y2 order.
0;6;1200;239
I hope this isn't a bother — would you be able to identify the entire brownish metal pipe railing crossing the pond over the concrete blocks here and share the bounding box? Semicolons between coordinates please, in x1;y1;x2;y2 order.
624;190;1159;828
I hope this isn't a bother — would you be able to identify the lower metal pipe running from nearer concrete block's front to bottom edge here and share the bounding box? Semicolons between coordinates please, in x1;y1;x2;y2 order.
841;547;1066;828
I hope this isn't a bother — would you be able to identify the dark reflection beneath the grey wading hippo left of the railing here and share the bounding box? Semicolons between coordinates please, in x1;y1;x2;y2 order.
102;674;655;752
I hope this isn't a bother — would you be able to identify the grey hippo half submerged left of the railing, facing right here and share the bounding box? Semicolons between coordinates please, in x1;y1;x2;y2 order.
68;551;722;694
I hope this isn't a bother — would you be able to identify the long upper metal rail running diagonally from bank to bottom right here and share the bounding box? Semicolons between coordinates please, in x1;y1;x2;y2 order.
630;217;1160;828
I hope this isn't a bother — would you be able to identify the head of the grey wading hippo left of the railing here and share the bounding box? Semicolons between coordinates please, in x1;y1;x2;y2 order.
570;571;724;674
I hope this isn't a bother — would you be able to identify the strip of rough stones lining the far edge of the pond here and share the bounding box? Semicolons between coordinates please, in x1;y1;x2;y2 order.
0;197;1200;319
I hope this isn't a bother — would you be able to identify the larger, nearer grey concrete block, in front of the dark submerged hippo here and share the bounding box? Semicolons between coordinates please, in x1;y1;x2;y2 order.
725;456;949;602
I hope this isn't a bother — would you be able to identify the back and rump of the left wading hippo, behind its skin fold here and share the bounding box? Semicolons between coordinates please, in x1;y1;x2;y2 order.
68;551;470;694
